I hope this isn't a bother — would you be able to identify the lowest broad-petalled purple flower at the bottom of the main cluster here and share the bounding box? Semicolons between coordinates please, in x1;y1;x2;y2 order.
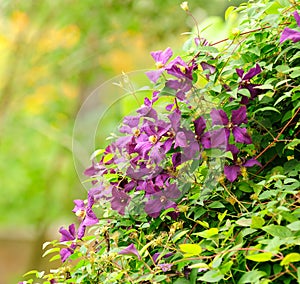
145;184;181;218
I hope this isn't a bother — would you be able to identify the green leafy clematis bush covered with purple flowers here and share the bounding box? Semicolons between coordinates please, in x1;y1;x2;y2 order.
22;0;300;284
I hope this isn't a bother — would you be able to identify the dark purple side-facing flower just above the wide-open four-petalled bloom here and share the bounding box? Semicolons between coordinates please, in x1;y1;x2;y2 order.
236;64;262;105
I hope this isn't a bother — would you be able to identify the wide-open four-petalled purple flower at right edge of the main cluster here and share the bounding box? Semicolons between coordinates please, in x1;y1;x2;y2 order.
210;106;252;144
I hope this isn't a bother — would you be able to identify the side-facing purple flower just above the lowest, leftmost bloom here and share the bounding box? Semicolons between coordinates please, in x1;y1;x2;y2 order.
72;195;99;239
